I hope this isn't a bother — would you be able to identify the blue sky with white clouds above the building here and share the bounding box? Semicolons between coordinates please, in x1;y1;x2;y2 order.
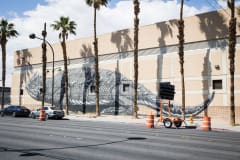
0;0;240;86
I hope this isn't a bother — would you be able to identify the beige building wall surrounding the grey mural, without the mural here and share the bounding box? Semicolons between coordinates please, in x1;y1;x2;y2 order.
12;7;240;122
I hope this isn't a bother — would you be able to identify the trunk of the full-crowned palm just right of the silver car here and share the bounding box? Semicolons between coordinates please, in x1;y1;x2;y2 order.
61;34;69;115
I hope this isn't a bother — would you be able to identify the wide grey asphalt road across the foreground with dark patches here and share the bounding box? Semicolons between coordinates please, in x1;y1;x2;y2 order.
0;117;240;160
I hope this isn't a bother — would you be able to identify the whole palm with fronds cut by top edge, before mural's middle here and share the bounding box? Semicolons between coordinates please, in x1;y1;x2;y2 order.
86;0;109;116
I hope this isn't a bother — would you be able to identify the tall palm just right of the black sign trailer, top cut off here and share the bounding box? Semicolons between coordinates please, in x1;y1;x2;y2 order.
178;0;185;120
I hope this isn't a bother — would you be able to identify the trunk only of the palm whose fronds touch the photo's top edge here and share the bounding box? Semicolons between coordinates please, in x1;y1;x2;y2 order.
93;7;100;116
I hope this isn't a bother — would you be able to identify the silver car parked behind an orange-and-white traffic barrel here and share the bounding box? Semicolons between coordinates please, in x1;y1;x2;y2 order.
30;106;64;119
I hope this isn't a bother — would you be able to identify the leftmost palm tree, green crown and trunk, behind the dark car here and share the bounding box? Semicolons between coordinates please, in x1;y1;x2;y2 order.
0;19;18;109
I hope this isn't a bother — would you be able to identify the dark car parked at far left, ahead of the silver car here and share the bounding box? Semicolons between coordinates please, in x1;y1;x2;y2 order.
0;105;31;117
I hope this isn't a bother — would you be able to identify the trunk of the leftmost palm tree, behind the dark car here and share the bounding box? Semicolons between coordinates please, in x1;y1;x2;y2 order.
1;40;6;109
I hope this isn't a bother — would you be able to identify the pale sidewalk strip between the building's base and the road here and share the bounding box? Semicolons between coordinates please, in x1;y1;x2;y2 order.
65;114;240;132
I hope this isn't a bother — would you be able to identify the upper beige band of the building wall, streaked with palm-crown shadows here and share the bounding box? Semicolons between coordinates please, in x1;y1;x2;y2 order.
14;10;240;67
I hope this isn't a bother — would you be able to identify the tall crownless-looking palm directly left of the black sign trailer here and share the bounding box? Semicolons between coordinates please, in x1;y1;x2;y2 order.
133;0;140;118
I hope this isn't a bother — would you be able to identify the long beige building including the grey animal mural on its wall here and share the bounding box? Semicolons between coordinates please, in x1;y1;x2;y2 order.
11;7;240;123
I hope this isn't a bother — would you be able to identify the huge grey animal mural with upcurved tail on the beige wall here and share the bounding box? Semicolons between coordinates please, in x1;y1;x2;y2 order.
26;66;214;116
